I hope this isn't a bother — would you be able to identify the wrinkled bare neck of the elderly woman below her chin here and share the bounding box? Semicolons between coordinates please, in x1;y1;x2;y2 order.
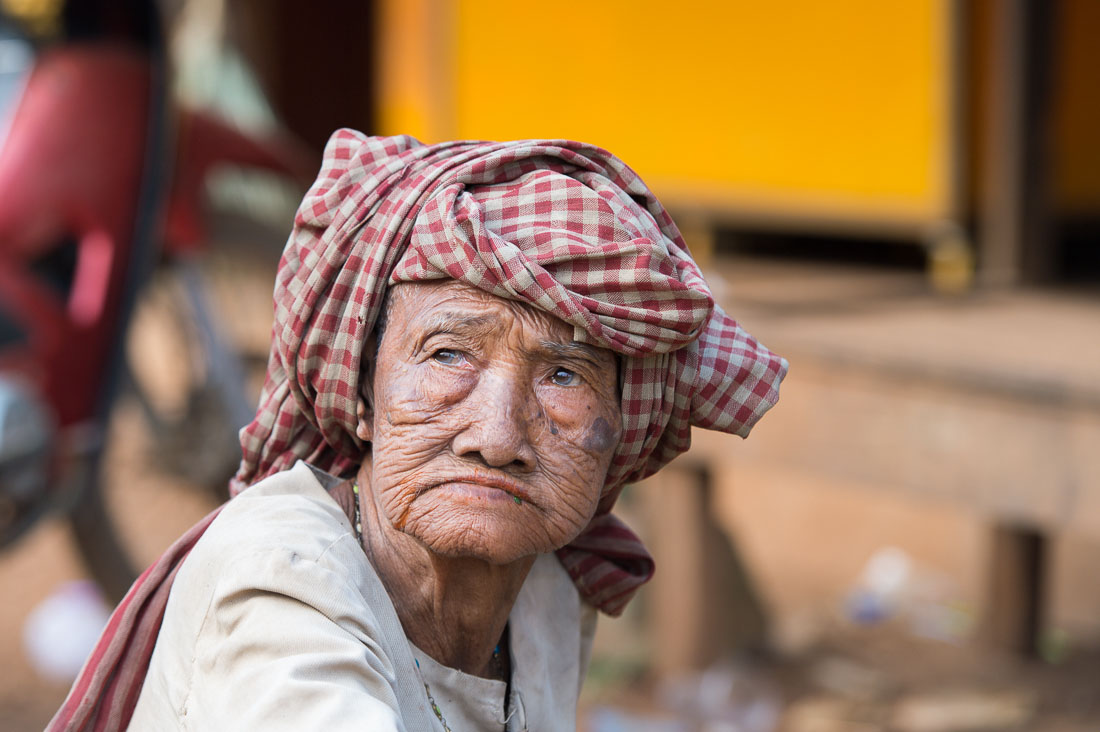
360;471;535;678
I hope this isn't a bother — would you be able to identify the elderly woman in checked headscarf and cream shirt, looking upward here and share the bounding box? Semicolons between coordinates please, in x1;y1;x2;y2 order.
52;130;787;731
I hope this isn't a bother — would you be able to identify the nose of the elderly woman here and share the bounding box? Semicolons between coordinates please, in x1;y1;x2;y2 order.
451;374;536;471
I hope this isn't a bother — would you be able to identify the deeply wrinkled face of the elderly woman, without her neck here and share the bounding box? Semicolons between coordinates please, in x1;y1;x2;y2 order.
365;280;622;564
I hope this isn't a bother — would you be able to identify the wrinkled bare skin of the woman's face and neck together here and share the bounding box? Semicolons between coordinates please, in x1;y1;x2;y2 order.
356;281;622;675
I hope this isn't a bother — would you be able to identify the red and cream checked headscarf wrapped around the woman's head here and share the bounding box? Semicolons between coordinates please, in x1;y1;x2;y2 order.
232;130;787;614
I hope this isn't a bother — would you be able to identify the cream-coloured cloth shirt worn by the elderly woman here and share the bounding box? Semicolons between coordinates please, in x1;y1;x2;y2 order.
130;462;595;732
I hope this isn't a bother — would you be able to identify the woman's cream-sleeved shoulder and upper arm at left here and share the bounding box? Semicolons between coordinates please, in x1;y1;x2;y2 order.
135;463;415;729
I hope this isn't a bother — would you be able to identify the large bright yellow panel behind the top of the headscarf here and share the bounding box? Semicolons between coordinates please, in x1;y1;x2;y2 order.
381;0;950;219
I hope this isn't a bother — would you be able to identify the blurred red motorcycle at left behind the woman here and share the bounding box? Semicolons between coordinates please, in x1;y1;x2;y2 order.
0;2;314;598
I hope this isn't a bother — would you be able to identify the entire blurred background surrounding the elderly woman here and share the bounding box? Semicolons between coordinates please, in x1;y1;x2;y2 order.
0;0;1100;732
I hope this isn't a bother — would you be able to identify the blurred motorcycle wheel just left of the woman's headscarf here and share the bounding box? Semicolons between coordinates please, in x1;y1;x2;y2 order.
70;246;273;600
